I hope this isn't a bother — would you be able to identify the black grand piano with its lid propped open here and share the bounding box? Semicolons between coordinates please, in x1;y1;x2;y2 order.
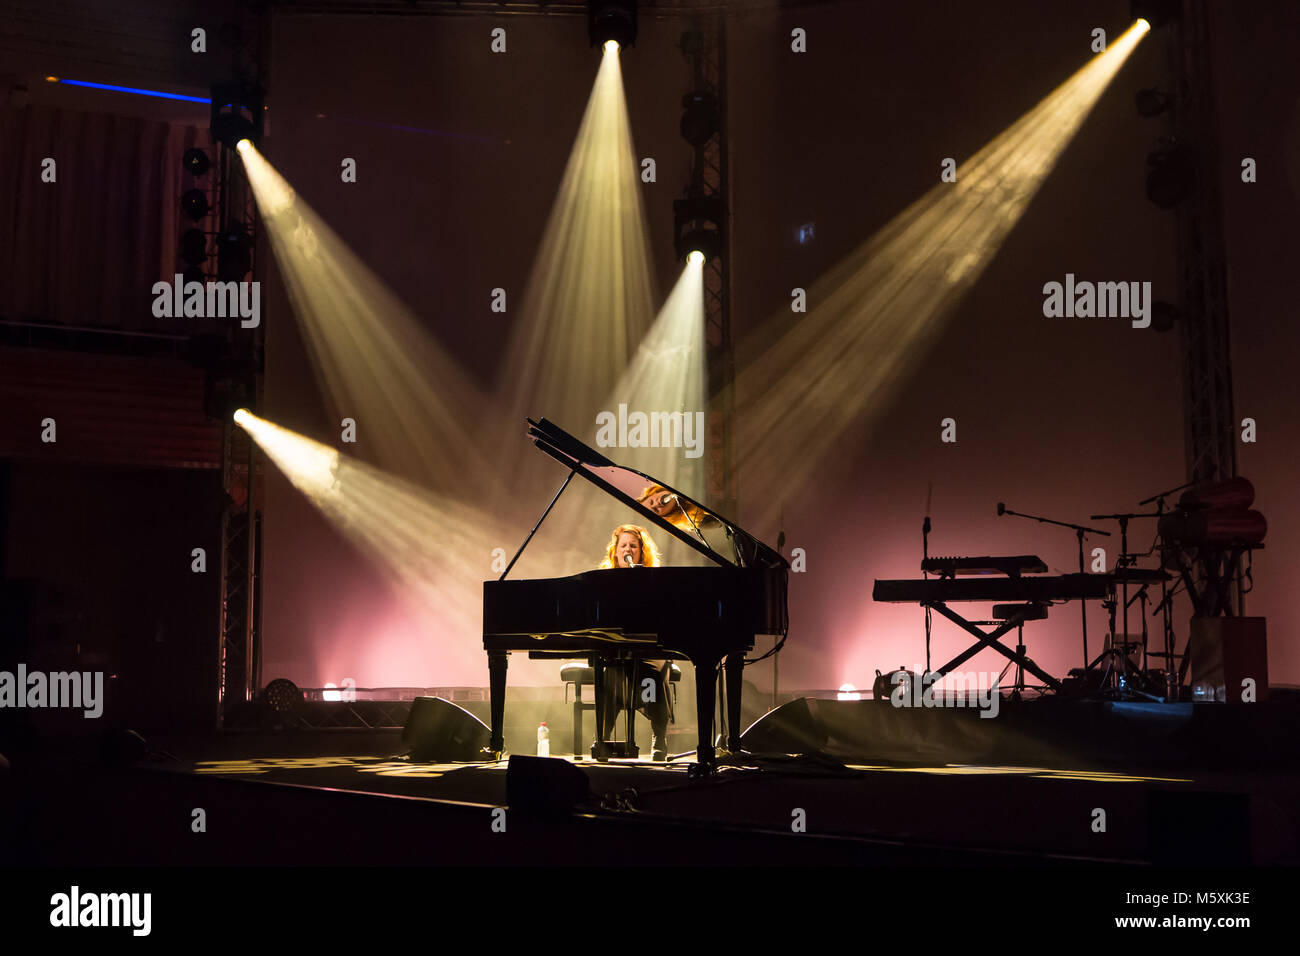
484;419;789;771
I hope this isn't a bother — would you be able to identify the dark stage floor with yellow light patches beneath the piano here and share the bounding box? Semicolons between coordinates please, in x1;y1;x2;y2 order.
8;731;1300;866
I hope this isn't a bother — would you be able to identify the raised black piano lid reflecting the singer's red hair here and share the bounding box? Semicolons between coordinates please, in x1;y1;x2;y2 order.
528;419;789;567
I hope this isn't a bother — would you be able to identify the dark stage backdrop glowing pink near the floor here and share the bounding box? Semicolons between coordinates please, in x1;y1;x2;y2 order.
256;0;1300;689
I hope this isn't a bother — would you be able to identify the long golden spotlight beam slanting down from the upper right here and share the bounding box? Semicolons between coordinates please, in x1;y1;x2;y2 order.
736;23;1147;527
